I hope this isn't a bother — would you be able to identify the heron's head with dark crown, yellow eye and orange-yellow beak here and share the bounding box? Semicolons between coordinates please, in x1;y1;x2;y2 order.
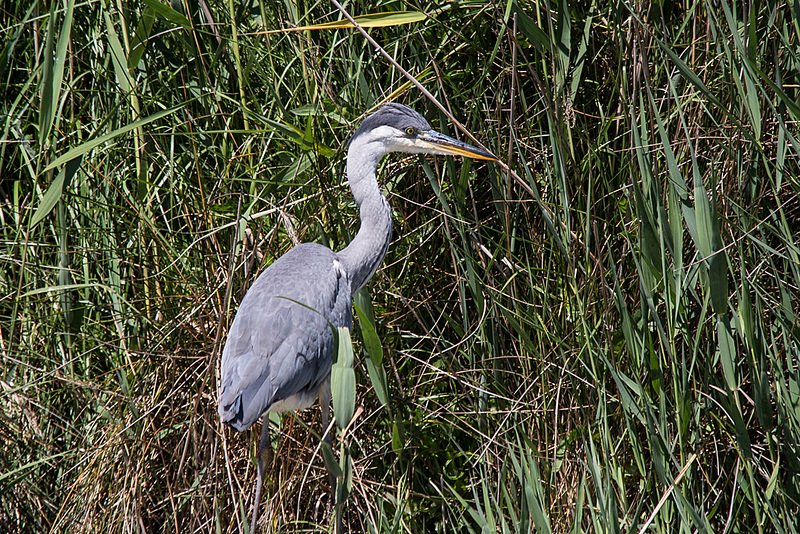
350;103;497;160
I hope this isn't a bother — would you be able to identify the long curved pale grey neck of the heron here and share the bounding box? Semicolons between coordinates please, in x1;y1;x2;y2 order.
338;142;392;293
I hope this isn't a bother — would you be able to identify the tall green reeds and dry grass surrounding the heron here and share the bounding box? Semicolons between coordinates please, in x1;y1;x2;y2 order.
0;0;800;534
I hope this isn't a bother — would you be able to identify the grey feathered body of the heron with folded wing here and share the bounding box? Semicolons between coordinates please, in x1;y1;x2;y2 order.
219;243;352;430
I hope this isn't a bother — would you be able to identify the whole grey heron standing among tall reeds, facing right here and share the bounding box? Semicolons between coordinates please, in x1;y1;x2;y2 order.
219;103;497;532
